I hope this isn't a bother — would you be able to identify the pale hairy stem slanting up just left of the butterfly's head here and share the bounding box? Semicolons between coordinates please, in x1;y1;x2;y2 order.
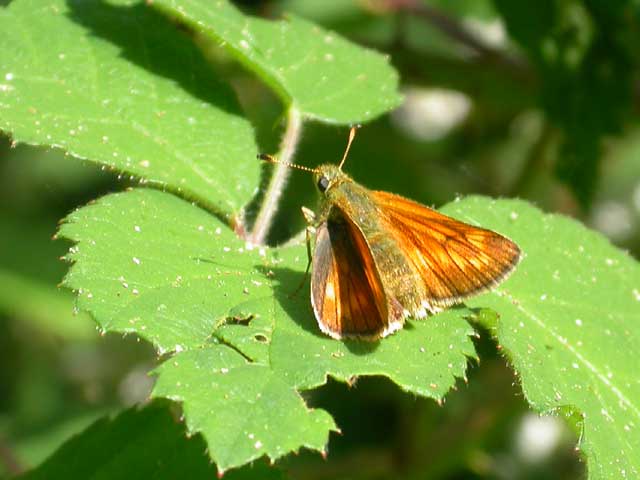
248;106;302;245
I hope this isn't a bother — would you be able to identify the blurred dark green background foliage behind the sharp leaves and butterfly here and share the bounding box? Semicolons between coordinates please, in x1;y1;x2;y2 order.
0;0;640;479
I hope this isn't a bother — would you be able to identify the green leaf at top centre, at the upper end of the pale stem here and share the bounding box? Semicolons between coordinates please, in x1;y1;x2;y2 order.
152;0;401;124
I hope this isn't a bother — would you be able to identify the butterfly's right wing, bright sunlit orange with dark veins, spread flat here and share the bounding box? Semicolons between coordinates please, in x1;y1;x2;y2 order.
371;191;520;310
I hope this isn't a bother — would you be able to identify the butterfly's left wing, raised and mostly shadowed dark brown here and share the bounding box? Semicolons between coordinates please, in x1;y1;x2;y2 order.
311;207;403;339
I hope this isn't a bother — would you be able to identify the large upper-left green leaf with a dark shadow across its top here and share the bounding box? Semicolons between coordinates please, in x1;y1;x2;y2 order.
0;0;259;217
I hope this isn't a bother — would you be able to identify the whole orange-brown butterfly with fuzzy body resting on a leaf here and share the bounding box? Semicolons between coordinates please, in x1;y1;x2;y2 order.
261;128;521;340
